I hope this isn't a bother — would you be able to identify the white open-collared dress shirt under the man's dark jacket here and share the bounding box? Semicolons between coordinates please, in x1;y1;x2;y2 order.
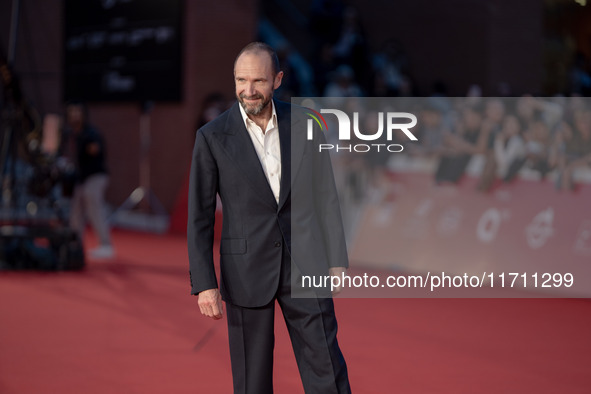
238;100;281;202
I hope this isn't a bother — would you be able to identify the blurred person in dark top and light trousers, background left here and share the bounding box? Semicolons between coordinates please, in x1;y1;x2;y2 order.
59;102;115;259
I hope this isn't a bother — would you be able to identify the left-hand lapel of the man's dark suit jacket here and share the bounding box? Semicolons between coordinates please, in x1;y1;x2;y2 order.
222;102;283;208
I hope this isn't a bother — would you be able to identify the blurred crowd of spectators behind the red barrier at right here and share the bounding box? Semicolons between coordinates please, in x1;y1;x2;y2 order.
302;95;591;199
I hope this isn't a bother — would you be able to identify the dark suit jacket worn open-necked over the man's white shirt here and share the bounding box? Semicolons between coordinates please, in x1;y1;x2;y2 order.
187;101;348;307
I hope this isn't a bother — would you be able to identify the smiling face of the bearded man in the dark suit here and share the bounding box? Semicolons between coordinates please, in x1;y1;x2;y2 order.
234;52;283;116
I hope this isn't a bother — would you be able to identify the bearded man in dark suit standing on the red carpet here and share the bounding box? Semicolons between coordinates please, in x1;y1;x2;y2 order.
188;43;351;394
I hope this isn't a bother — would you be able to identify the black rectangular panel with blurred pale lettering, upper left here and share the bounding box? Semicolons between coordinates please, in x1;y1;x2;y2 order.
64;0;183;102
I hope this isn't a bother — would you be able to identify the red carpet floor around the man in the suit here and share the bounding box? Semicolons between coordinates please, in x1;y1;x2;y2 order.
0;232;591;394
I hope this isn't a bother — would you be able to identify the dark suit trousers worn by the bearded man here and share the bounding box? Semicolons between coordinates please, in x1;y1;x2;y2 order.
226;246;351;394
